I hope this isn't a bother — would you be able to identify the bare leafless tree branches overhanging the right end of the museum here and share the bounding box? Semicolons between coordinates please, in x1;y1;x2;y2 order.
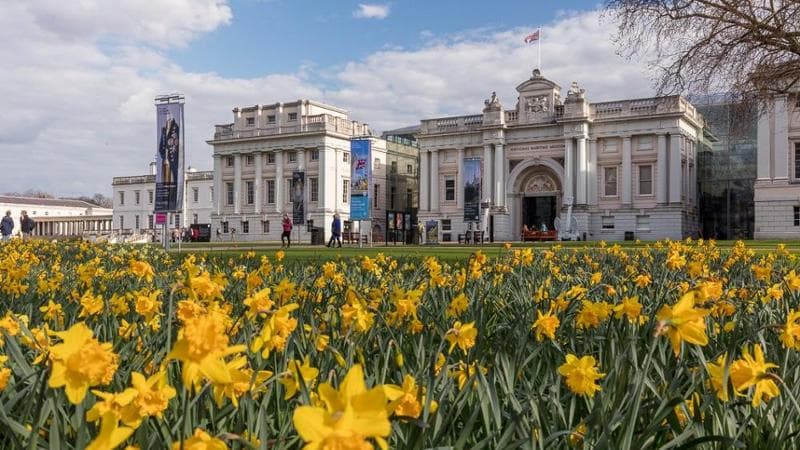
606;0;800;99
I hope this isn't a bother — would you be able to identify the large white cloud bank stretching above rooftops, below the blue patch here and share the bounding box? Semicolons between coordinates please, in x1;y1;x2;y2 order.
0;0;651;195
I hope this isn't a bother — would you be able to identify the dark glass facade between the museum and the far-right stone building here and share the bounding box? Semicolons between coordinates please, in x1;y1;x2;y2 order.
695;102;758;239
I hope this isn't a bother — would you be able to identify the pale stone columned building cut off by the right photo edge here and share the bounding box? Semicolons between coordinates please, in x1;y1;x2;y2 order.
754;86;800;239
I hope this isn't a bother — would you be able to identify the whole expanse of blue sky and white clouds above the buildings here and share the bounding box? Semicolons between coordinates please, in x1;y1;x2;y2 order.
0;0;652;196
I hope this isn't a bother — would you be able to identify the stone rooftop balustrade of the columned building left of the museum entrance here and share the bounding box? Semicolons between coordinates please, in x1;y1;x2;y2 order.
214;114;370;140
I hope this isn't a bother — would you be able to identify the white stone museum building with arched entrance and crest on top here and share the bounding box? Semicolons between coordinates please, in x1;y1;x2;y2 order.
417;70;705;241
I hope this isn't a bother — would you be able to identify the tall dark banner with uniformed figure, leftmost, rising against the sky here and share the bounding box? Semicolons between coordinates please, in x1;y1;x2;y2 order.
154;97;184;212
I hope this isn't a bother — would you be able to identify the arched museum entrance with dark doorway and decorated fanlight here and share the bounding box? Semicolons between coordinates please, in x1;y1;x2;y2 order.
507;158;563;236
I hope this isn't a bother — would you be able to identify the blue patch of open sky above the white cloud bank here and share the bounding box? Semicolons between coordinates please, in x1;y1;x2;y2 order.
170;0;598;77
